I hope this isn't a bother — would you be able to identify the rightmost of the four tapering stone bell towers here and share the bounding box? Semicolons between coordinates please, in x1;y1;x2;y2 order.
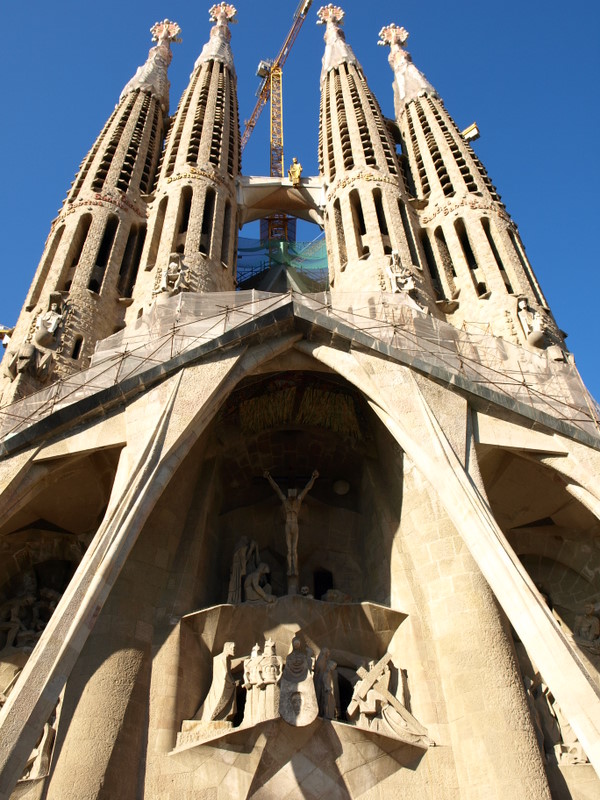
379;25;564;360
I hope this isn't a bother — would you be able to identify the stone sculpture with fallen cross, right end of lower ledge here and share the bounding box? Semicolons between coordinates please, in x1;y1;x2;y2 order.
347;653;432;747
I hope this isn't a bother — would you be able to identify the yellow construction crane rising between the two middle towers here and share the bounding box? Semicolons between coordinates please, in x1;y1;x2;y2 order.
242;0;312;241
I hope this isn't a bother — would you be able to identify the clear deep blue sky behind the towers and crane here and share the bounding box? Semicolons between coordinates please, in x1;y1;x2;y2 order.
0;0;600;398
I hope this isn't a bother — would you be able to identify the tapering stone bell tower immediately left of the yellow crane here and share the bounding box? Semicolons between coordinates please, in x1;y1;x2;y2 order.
127;3;241;323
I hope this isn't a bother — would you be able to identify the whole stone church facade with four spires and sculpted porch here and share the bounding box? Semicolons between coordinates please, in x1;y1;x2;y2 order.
0;3;600;800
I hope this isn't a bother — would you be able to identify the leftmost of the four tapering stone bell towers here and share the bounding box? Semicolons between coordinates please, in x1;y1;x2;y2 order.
0;20;179;403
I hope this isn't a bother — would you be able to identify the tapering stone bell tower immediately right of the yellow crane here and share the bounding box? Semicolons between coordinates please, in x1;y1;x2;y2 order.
318;4;435;306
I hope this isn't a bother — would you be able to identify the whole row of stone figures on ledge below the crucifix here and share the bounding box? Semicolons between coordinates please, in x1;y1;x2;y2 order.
179;636;433;748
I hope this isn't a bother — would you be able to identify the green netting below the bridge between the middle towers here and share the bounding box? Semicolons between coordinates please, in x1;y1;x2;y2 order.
237;236;328;291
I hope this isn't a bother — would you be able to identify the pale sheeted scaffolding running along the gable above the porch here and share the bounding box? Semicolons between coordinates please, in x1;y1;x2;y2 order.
0;290;600;449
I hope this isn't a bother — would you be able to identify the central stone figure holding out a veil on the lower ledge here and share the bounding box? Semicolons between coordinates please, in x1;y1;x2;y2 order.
279;636;319;727
